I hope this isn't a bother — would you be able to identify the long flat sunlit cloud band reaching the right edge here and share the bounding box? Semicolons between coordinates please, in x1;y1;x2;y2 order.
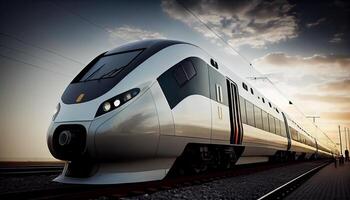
253;52;350;69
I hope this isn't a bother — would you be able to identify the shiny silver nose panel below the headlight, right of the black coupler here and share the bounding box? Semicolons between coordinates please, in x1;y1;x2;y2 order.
90;90;159;161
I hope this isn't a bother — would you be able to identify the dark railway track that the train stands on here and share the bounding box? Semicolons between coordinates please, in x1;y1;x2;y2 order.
0;162;330;199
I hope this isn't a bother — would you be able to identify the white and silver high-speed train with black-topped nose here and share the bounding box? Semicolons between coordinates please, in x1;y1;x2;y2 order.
47;40;337;184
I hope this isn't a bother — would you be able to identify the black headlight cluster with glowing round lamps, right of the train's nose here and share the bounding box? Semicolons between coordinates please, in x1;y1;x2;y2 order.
95;88;140;117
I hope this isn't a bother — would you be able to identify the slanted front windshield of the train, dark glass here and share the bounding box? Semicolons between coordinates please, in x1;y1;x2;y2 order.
79;50;142;82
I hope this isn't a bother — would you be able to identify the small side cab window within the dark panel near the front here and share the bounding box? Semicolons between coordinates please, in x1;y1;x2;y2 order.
174;60;196;86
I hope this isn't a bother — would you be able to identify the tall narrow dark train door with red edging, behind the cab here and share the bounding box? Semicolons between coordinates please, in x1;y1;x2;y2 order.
227;79;243;144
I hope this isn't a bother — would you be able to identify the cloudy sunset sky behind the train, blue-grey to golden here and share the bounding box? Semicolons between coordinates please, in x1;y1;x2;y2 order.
0;0;350;161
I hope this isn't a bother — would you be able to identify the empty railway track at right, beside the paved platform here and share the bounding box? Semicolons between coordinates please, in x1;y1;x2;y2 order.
258;162;329;200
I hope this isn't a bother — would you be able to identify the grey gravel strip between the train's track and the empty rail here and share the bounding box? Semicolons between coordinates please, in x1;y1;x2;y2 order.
124;161;321;200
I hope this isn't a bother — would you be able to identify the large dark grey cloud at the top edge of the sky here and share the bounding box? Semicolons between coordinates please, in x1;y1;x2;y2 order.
161;0;298;48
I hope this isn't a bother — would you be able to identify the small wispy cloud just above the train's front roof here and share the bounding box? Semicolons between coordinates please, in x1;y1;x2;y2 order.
109;26;166;41
